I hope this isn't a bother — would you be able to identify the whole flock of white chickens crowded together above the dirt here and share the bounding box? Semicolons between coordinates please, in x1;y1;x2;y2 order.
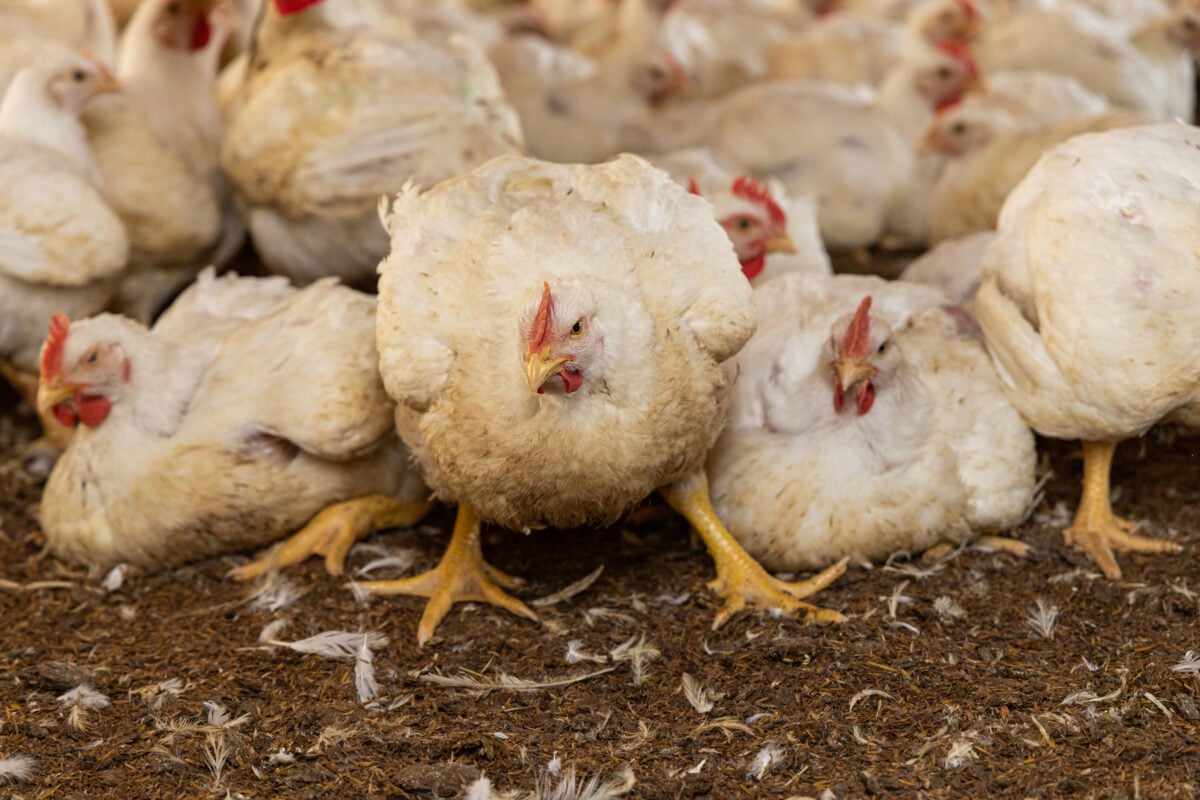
0;0;1200;643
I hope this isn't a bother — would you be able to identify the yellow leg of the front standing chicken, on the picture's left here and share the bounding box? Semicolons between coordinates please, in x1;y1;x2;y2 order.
359;503;539;646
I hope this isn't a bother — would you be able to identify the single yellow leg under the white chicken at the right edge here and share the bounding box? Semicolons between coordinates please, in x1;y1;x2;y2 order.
1062;441;1183;578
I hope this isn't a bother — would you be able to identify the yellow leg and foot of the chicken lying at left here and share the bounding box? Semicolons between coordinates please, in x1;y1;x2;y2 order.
229;494;433;581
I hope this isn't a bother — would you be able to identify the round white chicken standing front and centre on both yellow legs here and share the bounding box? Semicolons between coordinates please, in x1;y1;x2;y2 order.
259;156;845;643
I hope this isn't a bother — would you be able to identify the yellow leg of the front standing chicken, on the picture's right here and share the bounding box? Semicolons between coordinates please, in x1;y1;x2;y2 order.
659;471;850;630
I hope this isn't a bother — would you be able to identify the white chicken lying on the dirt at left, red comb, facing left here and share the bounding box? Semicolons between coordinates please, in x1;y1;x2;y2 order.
38;270;428;575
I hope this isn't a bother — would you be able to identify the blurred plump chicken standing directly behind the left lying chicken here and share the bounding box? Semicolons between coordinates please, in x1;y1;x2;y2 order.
221;2;522;287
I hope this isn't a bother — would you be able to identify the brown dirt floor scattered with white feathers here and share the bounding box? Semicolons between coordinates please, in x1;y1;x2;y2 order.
0;303;1200;800
